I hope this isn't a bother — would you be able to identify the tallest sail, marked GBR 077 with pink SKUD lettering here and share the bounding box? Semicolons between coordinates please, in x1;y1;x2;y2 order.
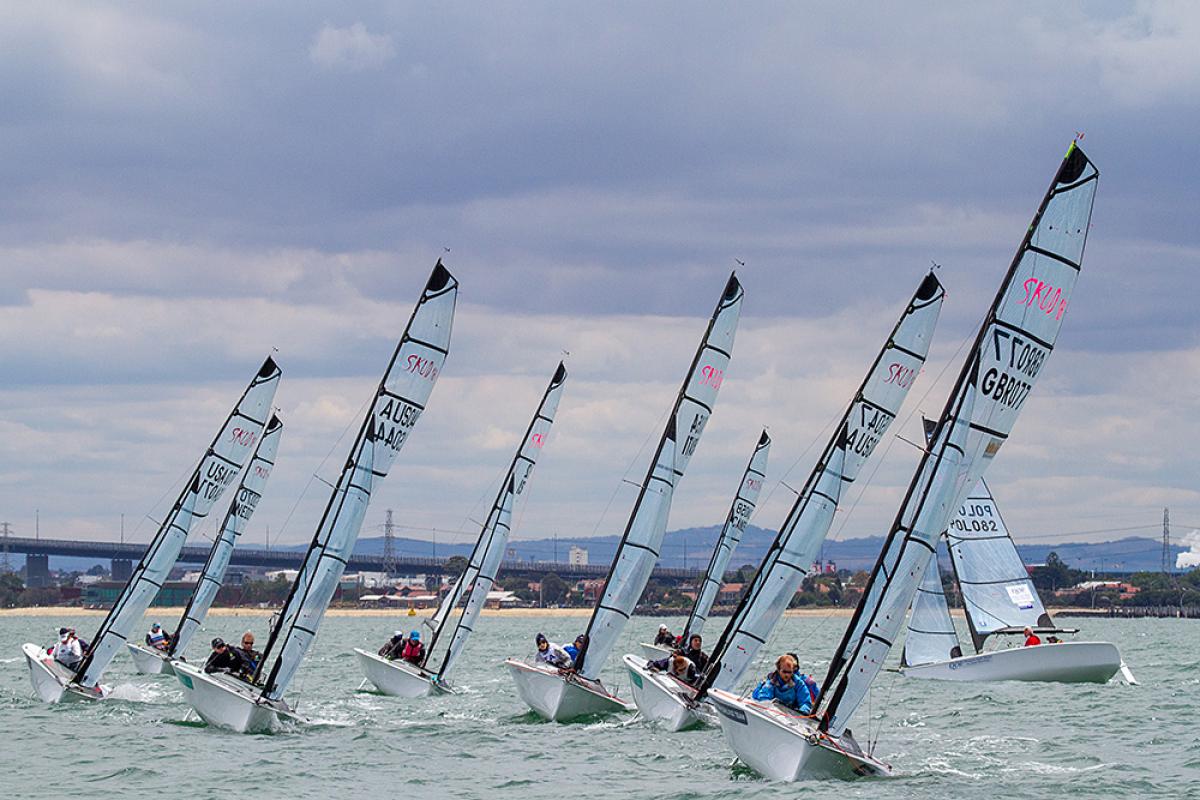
821;144;1099;735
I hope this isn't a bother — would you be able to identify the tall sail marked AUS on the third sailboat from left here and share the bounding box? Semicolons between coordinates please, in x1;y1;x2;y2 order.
256;261;458;700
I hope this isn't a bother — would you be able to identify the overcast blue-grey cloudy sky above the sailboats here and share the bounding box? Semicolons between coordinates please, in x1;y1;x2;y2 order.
0;2;1200;566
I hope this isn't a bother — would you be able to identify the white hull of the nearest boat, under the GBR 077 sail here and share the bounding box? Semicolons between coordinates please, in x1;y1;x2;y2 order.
708;688;892;781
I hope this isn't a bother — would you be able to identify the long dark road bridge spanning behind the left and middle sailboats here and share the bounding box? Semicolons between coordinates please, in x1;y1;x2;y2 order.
0;536;700;587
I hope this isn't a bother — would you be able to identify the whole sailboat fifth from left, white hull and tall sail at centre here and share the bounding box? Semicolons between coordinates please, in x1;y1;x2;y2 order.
504;275;745;722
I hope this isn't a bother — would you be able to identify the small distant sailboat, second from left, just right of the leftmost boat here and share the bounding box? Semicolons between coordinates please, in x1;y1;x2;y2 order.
125;414;283;674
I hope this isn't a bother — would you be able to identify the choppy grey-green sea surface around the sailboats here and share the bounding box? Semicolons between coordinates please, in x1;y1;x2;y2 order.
0;615;1200;800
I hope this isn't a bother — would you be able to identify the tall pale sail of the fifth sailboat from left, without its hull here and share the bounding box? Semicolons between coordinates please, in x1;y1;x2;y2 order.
576;275;745;680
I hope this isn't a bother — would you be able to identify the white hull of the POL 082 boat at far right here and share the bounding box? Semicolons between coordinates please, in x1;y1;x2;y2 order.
900;642;1121;684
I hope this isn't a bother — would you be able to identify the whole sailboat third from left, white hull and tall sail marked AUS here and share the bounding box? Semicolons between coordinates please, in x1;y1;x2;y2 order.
172;260;458;733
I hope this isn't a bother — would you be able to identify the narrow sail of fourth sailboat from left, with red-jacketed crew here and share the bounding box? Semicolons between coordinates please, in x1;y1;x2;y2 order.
426;362;566;679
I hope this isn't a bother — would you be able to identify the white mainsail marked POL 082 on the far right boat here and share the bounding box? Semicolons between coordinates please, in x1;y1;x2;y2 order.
946;479;1054;652
